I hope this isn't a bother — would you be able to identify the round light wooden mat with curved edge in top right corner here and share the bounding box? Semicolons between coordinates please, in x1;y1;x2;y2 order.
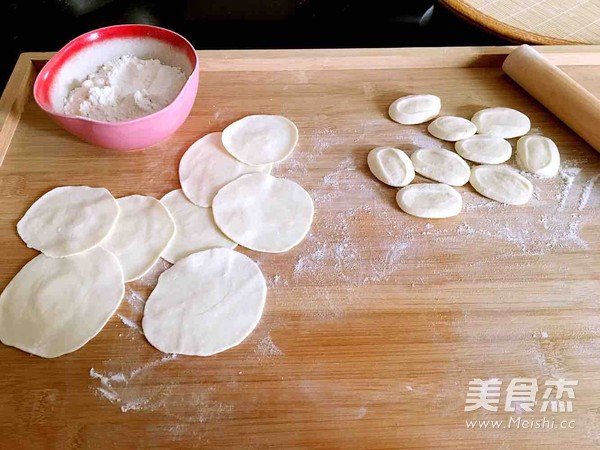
441;0;600;45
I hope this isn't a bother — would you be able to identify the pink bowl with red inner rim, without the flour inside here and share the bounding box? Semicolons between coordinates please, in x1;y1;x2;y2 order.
33;25;199;151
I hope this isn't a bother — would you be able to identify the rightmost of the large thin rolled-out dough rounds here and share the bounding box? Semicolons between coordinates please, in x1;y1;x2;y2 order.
213;173;314;253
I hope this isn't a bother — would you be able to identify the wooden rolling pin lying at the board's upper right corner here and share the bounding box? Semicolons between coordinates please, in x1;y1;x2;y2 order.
502;45;600;152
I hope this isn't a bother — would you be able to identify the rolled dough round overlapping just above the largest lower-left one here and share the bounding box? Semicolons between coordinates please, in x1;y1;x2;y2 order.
17;186;119;258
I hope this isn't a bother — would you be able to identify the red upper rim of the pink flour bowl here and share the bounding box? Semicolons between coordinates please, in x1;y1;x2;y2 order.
33;23;200;127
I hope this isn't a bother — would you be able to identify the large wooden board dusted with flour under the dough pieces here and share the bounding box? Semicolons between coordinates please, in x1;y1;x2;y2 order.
0;47;600;449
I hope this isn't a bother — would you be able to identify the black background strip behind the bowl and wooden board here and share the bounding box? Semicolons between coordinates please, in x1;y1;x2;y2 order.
0;0;507;89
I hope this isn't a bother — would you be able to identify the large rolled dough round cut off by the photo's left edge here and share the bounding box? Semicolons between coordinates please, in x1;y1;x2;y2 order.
0;247;125;358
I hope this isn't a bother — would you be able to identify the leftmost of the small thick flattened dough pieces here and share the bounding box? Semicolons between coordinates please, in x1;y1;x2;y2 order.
367;147;415;187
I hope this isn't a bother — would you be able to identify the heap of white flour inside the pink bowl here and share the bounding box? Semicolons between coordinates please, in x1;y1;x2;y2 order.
64;55;187;122
